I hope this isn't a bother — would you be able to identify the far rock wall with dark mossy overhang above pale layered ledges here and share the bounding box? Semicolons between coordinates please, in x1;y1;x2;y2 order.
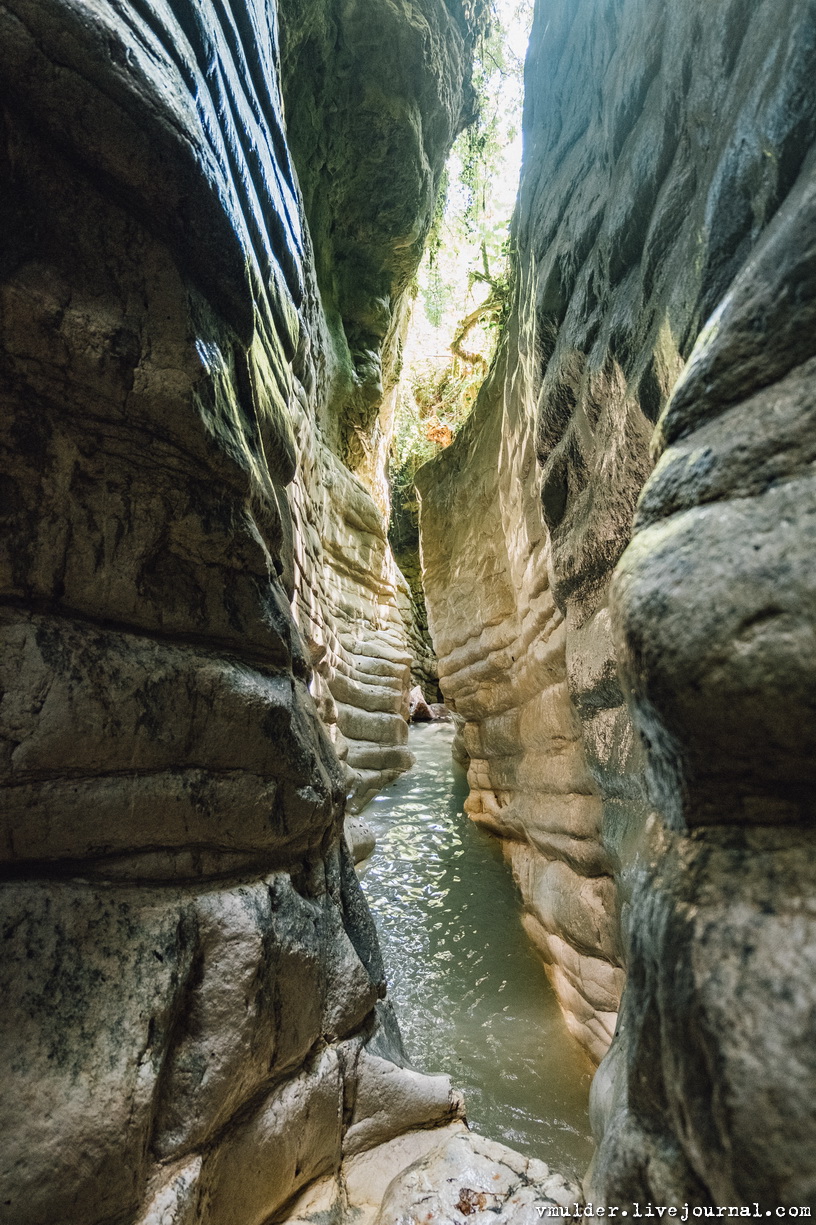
281;0;472;810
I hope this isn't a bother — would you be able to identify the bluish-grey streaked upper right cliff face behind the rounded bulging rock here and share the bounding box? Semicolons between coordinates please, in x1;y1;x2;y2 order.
518;0;814;837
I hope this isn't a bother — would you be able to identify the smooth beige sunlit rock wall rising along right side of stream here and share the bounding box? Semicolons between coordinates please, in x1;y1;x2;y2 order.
417;321;624;1062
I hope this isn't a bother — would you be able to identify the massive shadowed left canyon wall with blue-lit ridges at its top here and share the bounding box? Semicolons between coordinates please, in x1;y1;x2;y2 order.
0;0;464;1225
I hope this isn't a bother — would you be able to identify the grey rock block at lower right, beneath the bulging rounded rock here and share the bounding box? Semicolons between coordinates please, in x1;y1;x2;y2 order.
586;818;816;1214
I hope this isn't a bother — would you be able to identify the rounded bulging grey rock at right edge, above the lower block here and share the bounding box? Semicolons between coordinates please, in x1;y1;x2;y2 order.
616;162;816;829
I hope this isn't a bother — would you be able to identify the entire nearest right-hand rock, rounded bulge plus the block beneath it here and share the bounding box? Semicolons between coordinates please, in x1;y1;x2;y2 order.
594;45;816;1195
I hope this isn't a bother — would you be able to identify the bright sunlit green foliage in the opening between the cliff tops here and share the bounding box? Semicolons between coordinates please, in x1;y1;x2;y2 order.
391;0;532;519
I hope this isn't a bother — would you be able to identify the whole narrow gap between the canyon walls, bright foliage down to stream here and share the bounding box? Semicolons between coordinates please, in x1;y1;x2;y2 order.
361;0;593;1177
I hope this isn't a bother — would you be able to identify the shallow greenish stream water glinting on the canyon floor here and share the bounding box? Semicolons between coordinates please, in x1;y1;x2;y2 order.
363;724;592;1175
